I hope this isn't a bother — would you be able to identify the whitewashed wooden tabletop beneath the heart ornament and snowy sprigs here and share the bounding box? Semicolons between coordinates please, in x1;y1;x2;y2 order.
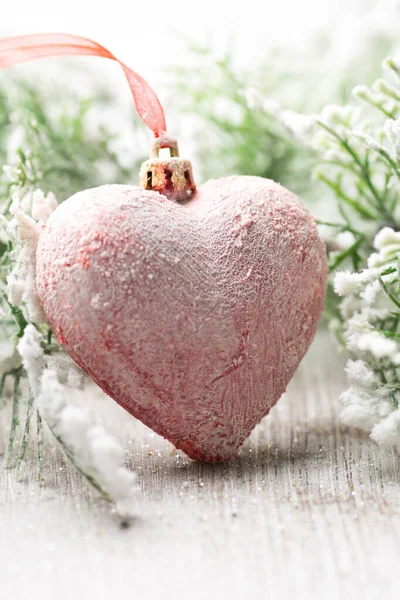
0;335;400;600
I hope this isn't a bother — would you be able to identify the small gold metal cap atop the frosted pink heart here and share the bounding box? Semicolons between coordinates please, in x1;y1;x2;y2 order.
140;134;196;202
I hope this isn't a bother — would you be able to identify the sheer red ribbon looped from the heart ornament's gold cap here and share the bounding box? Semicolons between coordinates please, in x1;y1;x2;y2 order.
0;33;167;137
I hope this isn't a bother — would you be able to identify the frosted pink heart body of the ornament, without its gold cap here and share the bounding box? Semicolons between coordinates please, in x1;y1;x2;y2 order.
37;177;327;462
